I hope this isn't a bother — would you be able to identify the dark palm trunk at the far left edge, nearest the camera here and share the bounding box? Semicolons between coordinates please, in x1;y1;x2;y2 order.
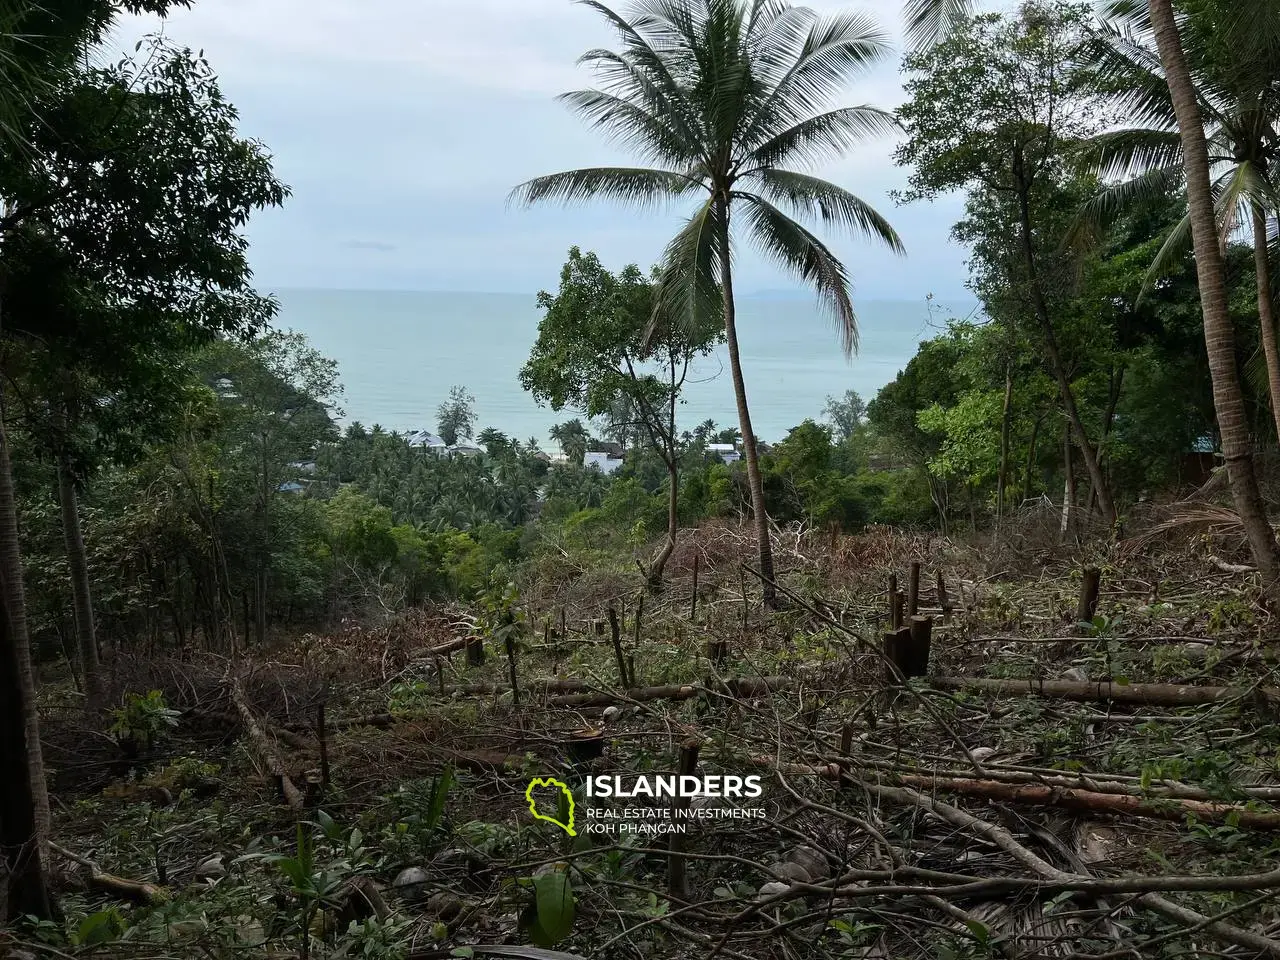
0;363;56;920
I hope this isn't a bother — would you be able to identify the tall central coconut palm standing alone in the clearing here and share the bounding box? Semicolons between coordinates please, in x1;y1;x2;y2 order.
513;0;902;607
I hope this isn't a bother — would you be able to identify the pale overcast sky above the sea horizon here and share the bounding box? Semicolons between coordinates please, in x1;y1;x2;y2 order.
116;0;965;300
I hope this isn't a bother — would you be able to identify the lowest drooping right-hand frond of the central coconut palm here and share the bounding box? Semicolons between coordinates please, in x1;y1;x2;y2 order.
733;193;858;356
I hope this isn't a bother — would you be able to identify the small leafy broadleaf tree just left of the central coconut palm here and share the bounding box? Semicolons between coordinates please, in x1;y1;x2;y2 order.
520;247;721;584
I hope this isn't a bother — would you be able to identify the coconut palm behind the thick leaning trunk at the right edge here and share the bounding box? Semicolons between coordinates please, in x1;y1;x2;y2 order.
1085;0;1280;438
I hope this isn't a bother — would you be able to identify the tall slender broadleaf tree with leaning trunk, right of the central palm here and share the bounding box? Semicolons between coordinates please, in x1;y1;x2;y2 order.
899;3;1116;524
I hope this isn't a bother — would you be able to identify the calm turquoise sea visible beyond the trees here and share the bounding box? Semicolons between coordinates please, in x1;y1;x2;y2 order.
276;289;970;449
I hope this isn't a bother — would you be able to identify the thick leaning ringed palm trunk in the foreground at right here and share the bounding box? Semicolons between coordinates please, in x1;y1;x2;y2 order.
1147;0;1280;586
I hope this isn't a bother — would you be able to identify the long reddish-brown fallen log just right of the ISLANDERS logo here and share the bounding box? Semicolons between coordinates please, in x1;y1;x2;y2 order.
751;756;1280;829
